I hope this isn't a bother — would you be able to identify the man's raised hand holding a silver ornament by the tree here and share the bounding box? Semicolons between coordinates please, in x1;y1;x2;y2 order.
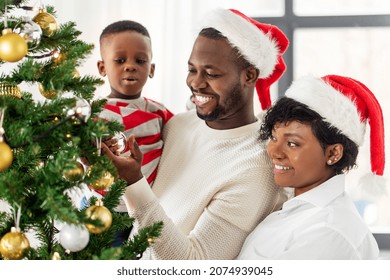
102;135;143;185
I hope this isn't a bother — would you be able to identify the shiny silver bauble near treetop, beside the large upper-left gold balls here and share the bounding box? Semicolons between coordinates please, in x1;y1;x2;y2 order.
14;16;42;50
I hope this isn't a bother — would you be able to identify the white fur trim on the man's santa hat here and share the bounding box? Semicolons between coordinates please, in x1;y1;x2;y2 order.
201;9;279;79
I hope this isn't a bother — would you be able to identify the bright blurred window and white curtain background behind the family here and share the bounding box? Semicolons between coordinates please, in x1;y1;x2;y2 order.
5;0;390;258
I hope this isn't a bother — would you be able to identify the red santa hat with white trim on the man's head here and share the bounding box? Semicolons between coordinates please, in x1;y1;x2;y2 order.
201;9;289;110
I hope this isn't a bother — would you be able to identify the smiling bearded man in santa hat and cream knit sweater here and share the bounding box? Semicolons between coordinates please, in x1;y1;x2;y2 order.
103;10;288;259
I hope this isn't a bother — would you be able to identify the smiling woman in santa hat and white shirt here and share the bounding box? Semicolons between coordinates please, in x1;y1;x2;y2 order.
238;75;384;259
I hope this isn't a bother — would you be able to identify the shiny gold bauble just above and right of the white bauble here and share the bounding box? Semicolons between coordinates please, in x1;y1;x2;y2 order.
85;200;112;234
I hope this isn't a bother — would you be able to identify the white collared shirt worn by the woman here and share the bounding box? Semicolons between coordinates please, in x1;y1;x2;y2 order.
238;175;379;260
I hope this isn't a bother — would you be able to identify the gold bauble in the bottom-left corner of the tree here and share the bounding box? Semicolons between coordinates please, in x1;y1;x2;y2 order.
0;227;30;260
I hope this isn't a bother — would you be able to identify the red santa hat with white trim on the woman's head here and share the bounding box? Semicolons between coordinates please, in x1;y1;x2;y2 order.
286;75;385;175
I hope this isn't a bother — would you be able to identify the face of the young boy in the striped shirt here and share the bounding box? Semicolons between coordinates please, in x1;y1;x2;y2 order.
98;31;155;99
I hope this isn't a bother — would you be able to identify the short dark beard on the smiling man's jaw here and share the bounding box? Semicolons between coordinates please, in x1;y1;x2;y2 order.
196;83;242;121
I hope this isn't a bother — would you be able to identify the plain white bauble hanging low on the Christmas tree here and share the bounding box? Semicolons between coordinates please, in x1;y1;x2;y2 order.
60;224;89;252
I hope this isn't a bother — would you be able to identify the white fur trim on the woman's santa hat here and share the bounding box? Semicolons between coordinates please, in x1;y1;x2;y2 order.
285;76;366;146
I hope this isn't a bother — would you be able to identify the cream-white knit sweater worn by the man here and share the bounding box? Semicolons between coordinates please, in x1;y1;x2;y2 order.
124;110;283;260
